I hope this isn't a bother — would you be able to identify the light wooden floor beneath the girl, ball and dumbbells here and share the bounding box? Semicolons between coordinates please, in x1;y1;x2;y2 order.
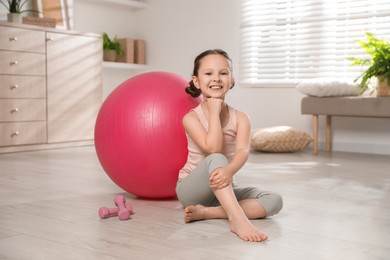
0;147;390;260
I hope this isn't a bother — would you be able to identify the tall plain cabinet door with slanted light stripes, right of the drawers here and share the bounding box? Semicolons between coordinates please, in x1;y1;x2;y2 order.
47;32;102;143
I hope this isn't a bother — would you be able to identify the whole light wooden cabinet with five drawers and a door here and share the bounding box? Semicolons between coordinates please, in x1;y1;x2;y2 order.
0;22;103;153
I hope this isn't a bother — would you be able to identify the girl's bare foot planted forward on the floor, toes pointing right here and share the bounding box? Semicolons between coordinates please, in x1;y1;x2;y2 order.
230;219;268;242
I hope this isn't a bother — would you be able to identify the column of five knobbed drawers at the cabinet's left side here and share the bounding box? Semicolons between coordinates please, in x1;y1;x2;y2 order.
0;26;47;149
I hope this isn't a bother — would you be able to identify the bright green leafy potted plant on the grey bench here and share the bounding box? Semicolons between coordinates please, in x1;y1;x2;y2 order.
348;32;390;96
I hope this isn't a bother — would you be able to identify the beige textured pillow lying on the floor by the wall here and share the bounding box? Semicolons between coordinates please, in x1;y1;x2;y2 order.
251;126;312;152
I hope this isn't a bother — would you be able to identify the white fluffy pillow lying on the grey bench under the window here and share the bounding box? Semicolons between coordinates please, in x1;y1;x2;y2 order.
296;78;361;97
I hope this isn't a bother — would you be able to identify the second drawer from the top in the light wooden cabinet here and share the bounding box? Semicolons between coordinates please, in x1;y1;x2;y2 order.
0;51;46;76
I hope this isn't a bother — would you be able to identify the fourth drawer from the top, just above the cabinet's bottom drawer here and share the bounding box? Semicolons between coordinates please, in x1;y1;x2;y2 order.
0;99;46;122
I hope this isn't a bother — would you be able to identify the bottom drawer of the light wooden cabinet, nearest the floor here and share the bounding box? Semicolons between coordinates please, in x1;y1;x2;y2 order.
0;121;46;146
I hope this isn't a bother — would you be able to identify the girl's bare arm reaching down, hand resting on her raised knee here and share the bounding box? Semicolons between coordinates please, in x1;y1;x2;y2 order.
210;111;251;189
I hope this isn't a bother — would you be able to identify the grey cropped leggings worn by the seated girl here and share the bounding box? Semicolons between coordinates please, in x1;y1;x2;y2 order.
176;153;283;216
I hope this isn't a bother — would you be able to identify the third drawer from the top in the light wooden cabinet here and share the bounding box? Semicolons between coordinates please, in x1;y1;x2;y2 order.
0;75;46;98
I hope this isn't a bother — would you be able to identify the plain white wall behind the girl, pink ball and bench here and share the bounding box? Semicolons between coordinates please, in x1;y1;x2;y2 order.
0;0;390;154
